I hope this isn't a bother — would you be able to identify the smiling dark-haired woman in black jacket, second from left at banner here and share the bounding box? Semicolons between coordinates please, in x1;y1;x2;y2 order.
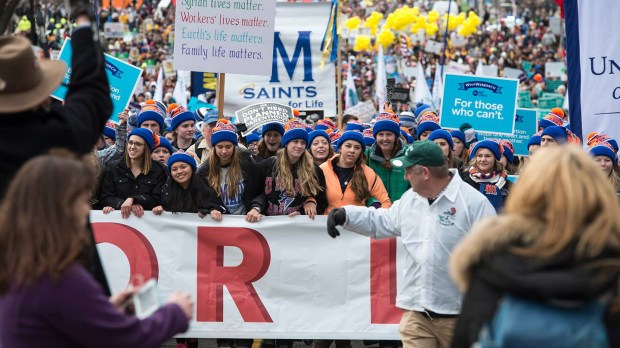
153;152;226;221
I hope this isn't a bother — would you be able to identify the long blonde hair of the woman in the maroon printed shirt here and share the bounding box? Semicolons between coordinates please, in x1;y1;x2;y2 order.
274;147;323;197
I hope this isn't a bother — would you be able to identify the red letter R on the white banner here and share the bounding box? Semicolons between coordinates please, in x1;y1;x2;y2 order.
196;227;273;323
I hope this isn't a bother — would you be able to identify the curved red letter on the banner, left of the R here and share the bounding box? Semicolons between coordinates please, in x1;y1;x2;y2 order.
92;222;159;281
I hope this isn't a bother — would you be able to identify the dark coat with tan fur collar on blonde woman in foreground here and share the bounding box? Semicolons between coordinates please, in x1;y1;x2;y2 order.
450;216;620;348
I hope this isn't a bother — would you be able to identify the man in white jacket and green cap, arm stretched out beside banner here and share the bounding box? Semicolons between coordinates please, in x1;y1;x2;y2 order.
327;141;495;348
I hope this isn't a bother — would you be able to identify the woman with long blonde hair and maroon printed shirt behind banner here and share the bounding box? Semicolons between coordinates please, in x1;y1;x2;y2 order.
246;121;327;222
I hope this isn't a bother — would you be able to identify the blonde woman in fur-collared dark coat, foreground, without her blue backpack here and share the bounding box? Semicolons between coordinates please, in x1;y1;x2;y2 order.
450;145;620;347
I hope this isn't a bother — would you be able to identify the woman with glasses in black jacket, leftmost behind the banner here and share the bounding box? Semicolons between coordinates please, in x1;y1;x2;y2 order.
100;128;167;219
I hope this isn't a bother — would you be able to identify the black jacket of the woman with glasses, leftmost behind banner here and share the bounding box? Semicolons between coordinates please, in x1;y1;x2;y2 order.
99;159;168;210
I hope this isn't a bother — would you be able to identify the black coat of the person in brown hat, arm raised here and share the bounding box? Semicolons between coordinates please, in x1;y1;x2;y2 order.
0;28;112;198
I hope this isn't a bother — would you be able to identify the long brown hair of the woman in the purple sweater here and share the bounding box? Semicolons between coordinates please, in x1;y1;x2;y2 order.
0;155;95;294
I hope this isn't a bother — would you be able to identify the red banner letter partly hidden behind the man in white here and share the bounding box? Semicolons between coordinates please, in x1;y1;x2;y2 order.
370;238;402;324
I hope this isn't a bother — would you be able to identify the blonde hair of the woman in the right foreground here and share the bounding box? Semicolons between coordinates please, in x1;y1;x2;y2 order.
504;145;620;258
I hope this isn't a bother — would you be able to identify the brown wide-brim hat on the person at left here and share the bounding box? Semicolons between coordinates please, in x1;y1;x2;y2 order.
0;36;67;114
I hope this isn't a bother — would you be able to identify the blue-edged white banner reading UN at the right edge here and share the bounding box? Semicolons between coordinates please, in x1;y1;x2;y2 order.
564;0;620;139
